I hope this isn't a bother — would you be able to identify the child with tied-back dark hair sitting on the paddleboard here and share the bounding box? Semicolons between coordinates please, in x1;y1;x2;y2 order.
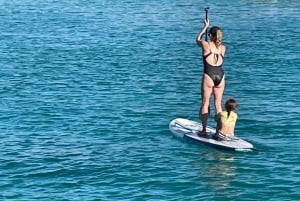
213;98;238;140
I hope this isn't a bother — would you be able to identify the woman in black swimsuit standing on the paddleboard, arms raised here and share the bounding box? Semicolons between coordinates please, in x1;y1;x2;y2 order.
196;18;226;136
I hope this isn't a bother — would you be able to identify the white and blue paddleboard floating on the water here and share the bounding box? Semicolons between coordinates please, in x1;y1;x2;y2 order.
169;118;255;151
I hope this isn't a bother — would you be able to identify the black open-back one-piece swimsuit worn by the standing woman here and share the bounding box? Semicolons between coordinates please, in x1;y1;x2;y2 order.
202;52;224;86
